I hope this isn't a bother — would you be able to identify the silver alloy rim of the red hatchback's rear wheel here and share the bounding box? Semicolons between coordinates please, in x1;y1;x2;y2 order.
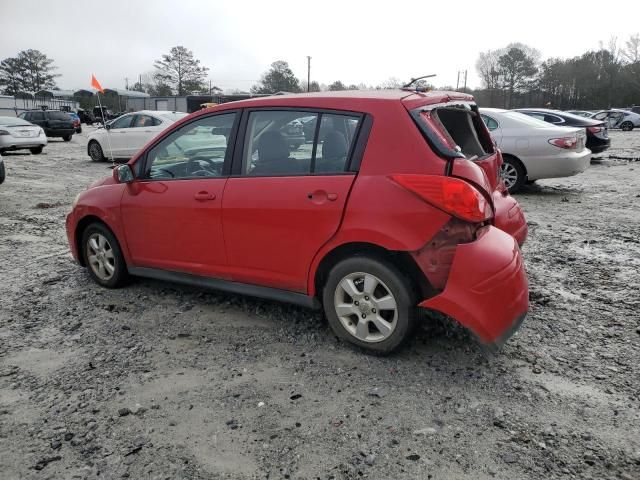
334;272;398;343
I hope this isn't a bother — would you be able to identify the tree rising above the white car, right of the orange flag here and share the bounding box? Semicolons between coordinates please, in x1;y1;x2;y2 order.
154;46;209;95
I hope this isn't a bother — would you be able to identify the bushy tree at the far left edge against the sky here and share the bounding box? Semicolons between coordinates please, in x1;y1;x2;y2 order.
0;49;60;95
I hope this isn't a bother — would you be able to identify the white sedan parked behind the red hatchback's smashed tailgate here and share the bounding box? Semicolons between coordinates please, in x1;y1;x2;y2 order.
480;108;591;192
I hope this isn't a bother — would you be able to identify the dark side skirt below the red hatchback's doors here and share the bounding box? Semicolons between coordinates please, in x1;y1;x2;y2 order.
128;267;320;310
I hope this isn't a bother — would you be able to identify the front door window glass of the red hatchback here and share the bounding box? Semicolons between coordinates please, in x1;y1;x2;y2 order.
143;113;236;180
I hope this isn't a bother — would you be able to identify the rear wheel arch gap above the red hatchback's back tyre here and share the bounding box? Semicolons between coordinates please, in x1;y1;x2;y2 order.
310;242;433;298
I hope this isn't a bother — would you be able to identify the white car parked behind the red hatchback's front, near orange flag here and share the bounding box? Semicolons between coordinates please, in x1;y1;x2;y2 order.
87;110;188;162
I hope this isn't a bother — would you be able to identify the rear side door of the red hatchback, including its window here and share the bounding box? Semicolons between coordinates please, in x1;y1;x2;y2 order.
223;109;362;292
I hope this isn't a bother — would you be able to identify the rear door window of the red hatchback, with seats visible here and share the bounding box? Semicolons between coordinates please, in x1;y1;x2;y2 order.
242;110;360;176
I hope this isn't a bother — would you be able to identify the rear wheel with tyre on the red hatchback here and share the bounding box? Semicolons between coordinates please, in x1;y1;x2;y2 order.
322;256;417;354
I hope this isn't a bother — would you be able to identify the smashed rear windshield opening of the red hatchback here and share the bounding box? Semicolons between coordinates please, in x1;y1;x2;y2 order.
412;103;494;159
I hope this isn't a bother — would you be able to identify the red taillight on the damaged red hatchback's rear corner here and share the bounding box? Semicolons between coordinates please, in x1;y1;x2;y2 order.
391;174;493;223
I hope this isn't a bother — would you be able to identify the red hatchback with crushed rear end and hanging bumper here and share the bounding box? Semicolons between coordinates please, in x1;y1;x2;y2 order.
67;90;528;353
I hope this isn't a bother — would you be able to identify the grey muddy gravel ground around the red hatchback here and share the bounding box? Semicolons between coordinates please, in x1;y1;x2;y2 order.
0;125;640;480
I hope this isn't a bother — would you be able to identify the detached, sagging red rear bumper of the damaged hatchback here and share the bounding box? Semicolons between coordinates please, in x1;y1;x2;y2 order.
418;226;529;345
